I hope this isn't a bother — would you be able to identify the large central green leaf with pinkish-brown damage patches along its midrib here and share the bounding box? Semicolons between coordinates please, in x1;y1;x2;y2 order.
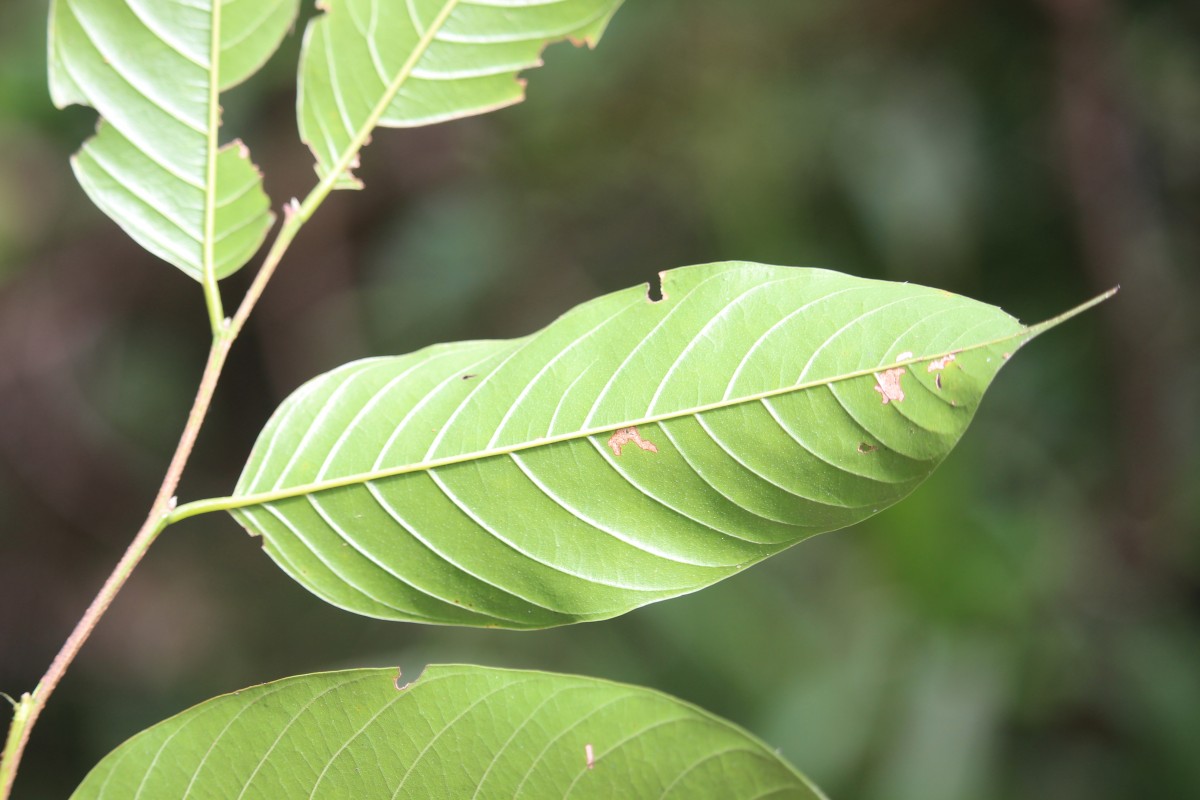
208;263;1104;628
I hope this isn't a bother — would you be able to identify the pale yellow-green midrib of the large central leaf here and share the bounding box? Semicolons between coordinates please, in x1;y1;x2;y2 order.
168;328;1032;524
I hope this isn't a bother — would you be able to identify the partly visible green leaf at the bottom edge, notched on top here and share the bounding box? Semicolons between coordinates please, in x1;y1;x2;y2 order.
72;666;823;800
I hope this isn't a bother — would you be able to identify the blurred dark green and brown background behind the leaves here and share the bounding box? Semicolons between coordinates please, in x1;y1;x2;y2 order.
0;0;1200;800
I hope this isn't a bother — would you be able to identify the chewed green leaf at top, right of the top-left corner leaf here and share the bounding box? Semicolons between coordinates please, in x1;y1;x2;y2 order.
298;0;622;188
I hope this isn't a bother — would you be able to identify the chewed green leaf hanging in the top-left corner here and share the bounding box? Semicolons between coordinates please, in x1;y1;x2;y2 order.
49;0;299;281
